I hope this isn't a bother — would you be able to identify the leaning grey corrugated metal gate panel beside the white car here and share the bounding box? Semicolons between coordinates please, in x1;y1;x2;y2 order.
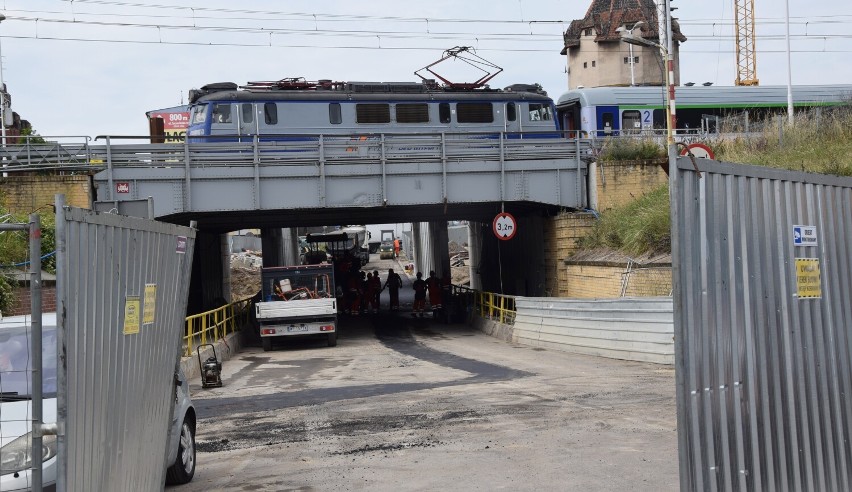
60;209;195;492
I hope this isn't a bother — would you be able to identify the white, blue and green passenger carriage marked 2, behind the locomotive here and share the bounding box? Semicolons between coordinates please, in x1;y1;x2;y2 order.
556;85;852;136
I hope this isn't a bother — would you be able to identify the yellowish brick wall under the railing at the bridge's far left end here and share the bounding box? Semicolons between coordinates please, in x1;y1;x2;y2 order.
0;175;94;214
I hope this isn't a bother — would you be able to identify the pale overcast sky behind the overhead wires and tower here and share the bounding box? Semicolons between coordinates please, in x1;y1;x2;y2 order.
0;0;852;137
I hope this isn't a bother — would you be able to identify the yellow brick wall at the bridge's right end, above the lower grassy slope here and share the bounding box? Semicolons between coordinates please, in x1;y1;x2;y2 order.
596;161;669;211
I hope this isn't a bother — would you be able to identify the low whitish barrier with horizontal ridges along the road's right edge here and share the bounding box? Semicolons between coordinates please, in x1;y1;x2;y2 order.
514;297;674;364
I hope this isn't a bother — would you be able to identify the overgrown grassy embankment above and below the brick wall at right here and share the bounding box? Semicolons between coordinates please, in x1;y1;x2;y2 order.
580;110;852;256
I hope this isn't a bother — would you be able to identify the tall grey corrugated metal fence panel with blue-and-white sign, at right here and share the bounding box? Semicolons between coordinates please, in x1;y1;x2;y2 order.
672;159;852;491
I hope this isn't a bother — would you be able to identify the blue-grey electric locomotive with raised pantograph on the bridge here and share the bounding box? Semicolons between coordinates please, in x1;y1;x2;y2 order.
187;79;559;141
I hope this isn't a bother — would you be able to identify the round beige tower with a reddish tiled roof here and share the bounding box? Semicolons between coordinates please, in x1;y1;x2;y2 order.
561;0;686;89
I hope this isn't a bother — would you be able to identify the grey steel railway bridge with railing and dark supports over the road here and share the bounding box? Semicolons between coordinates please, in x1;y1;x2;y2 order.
0;134;664;312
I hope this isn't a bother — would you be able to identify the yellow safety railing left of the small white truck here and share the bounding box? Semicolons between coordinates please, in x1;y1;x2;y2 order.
183;297;254;357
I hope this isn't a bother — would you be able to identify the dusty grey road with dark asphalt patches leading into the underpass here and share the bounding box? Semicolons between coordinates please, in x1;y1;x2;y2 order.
169;256;679;491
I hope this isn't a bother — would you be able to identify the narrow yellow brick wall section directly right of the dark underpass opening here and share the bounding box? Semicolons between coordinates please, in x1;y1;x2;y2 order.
544;213;595;297
